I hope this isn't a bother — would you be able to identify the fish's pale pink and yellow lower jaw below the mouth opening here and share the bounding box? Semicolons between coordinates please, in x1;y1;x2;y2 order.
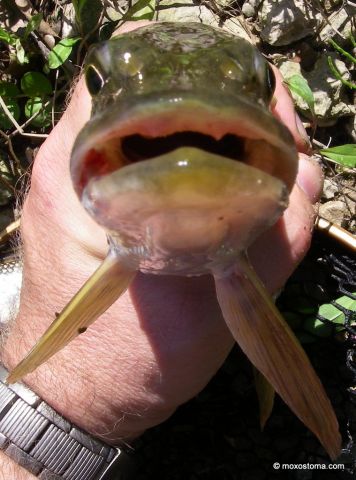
81;147;289;266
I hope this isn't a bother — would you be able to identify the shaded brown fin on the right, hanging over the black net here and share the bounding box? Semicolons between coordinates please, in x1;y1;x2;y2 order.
215;256;341;460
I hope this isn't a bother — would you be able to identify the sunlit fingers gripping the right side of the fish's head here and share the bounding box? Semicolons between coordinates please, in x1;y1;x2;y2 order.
249;61;323;292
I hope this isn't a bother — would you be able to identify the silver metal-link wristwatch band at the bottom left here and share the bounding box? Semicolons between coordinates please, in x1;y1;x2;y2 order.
0;365;134;480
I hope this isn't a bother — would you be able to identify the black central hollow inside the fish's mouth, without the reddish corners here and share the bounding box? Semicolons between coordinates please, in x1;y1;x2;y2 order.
121;131;245;163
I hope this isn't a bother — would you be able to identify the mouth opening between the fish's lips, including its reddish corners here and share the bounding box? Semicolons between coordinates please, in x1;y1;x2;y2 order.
77;130;294;195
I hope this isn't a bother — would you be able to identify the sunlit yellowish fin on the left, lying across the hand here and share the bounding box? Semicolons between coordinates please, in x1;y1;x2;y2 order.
6;252;136;383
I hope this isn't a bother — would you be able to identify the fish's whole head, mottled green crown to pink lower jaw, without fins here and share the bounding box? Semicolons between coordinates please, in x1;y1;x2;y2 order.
71;23;297;274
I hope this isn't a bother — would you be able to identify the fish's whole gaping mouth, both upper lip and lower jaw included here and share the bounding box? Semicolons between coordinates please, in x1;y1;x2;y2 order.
71;106;297;251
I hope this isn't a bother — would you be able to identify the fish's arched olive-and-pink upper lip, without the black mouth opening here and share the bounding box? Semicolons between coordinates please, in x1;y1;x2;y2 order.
71;92;297;197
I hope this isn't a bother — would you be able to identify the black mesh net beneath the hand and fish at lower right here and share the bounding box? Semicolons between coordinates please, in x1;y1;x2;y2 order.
137;234;356;480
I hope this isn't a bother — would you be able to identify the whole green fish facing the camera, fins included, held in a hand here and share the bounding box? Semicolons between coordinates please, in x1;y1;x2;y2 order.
7;22;341;459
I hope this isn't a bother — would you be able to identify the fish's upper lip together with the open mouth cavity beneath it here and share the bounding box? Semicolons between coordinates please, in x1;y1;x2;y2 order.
71;96;297;197
